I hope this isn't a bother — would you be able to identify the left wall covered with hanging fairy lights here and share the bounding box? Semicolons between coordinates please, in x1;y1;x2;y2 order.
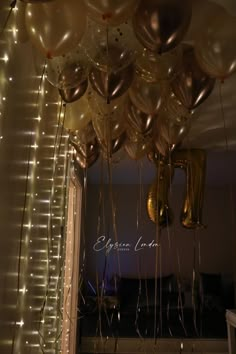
0;0;67;354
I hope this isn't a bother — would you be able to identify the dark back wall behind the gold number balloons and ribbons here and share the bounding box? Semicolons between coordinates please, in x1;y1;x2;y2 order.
86;181;235;292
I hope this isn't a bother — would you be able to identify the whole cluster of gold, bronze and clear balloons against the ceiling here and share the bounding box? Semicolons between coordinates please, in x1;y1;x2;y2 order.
22;0;236;168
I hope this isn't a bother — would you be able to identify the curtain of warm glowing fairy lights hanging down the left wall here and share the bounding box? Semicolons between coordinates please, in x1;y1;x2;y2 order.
0;2;79;354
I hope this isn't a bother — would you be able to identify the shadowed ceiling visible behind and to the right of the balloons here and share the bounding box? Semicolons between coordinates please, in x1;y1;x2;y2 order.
88;0;236;185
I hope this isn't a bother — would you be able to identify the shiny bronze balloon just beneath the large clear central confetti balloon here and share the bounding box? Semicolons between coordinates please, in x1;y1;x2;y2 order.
89;64;134;100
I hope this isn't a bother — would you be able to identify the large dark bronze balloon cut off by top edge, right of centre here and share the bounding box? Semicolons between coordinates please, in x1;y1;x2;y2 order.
133;0;192;54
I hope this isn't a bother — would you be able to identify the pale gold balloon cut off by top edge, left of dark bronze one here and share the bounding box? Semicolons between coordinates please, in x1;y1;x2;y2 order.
85;0;137;26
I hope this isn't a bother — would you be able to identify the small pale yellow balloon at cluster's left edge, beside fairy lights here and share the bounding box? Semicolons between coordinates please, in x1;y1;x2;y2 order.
64;96;93;132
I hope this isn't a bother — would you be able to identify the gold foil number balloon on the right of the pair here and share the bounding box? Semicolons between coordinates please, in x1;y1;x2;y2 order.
172;149;206;229
